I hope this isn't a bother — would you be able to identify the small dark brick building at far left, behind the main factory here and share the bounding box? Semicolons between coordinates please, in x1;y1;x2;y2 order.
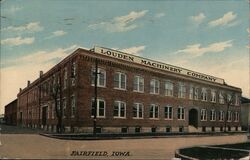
4;99;17;125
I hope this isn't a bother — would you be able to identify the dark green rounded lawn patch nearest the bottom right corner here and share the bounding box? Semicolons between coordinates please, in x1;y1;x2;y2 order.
180;147;249;159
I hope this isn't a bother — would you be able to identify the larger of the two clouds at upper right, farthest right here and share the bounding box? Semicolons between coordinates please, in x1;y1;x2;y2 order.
208;12;238;27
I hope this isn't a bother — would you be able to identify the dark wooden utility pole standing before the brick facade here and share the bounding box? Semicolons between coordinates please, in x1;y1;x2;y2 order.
93;58;100;136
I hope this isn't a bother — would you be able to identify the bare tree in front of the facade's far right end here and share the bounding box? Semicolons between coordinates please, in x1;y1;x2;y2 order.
223;92;236;132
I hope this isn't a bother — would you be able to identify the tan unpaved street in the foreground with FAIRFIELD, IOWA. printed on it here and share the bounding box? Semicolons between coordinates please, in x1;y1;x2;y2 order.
0;125;247;160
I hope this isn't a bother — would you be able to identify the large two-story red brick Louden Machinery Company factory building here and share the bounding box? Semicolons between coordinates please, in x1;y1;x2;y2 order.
17;47;241;133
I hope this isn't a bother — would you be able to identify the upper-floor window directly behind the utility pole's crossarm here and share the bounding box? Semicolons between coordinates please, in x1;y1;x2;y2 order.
91;68;106;87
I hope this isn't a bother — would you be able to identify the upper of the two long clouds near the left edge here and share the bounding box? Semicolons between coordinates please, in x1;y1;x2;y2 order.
2;22;43;32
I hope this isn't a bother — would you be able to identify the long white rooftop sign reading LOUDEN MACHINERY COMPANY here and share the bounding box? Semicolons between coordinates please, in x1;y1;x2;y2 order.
94;46;224;84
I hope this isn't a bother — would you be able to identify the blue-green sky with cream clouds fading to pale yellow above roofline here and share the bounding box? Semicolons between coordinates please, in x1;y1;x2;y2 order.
0;0;250;114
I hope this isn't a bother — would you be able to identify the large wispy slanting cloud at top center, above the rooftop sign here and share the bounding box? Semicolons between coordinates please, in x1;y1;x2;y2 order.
88;10;148;32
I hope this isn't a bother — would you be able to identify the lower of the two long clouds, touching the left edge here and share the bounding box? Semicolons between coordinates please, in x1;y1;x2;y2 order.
1;36;35;46
